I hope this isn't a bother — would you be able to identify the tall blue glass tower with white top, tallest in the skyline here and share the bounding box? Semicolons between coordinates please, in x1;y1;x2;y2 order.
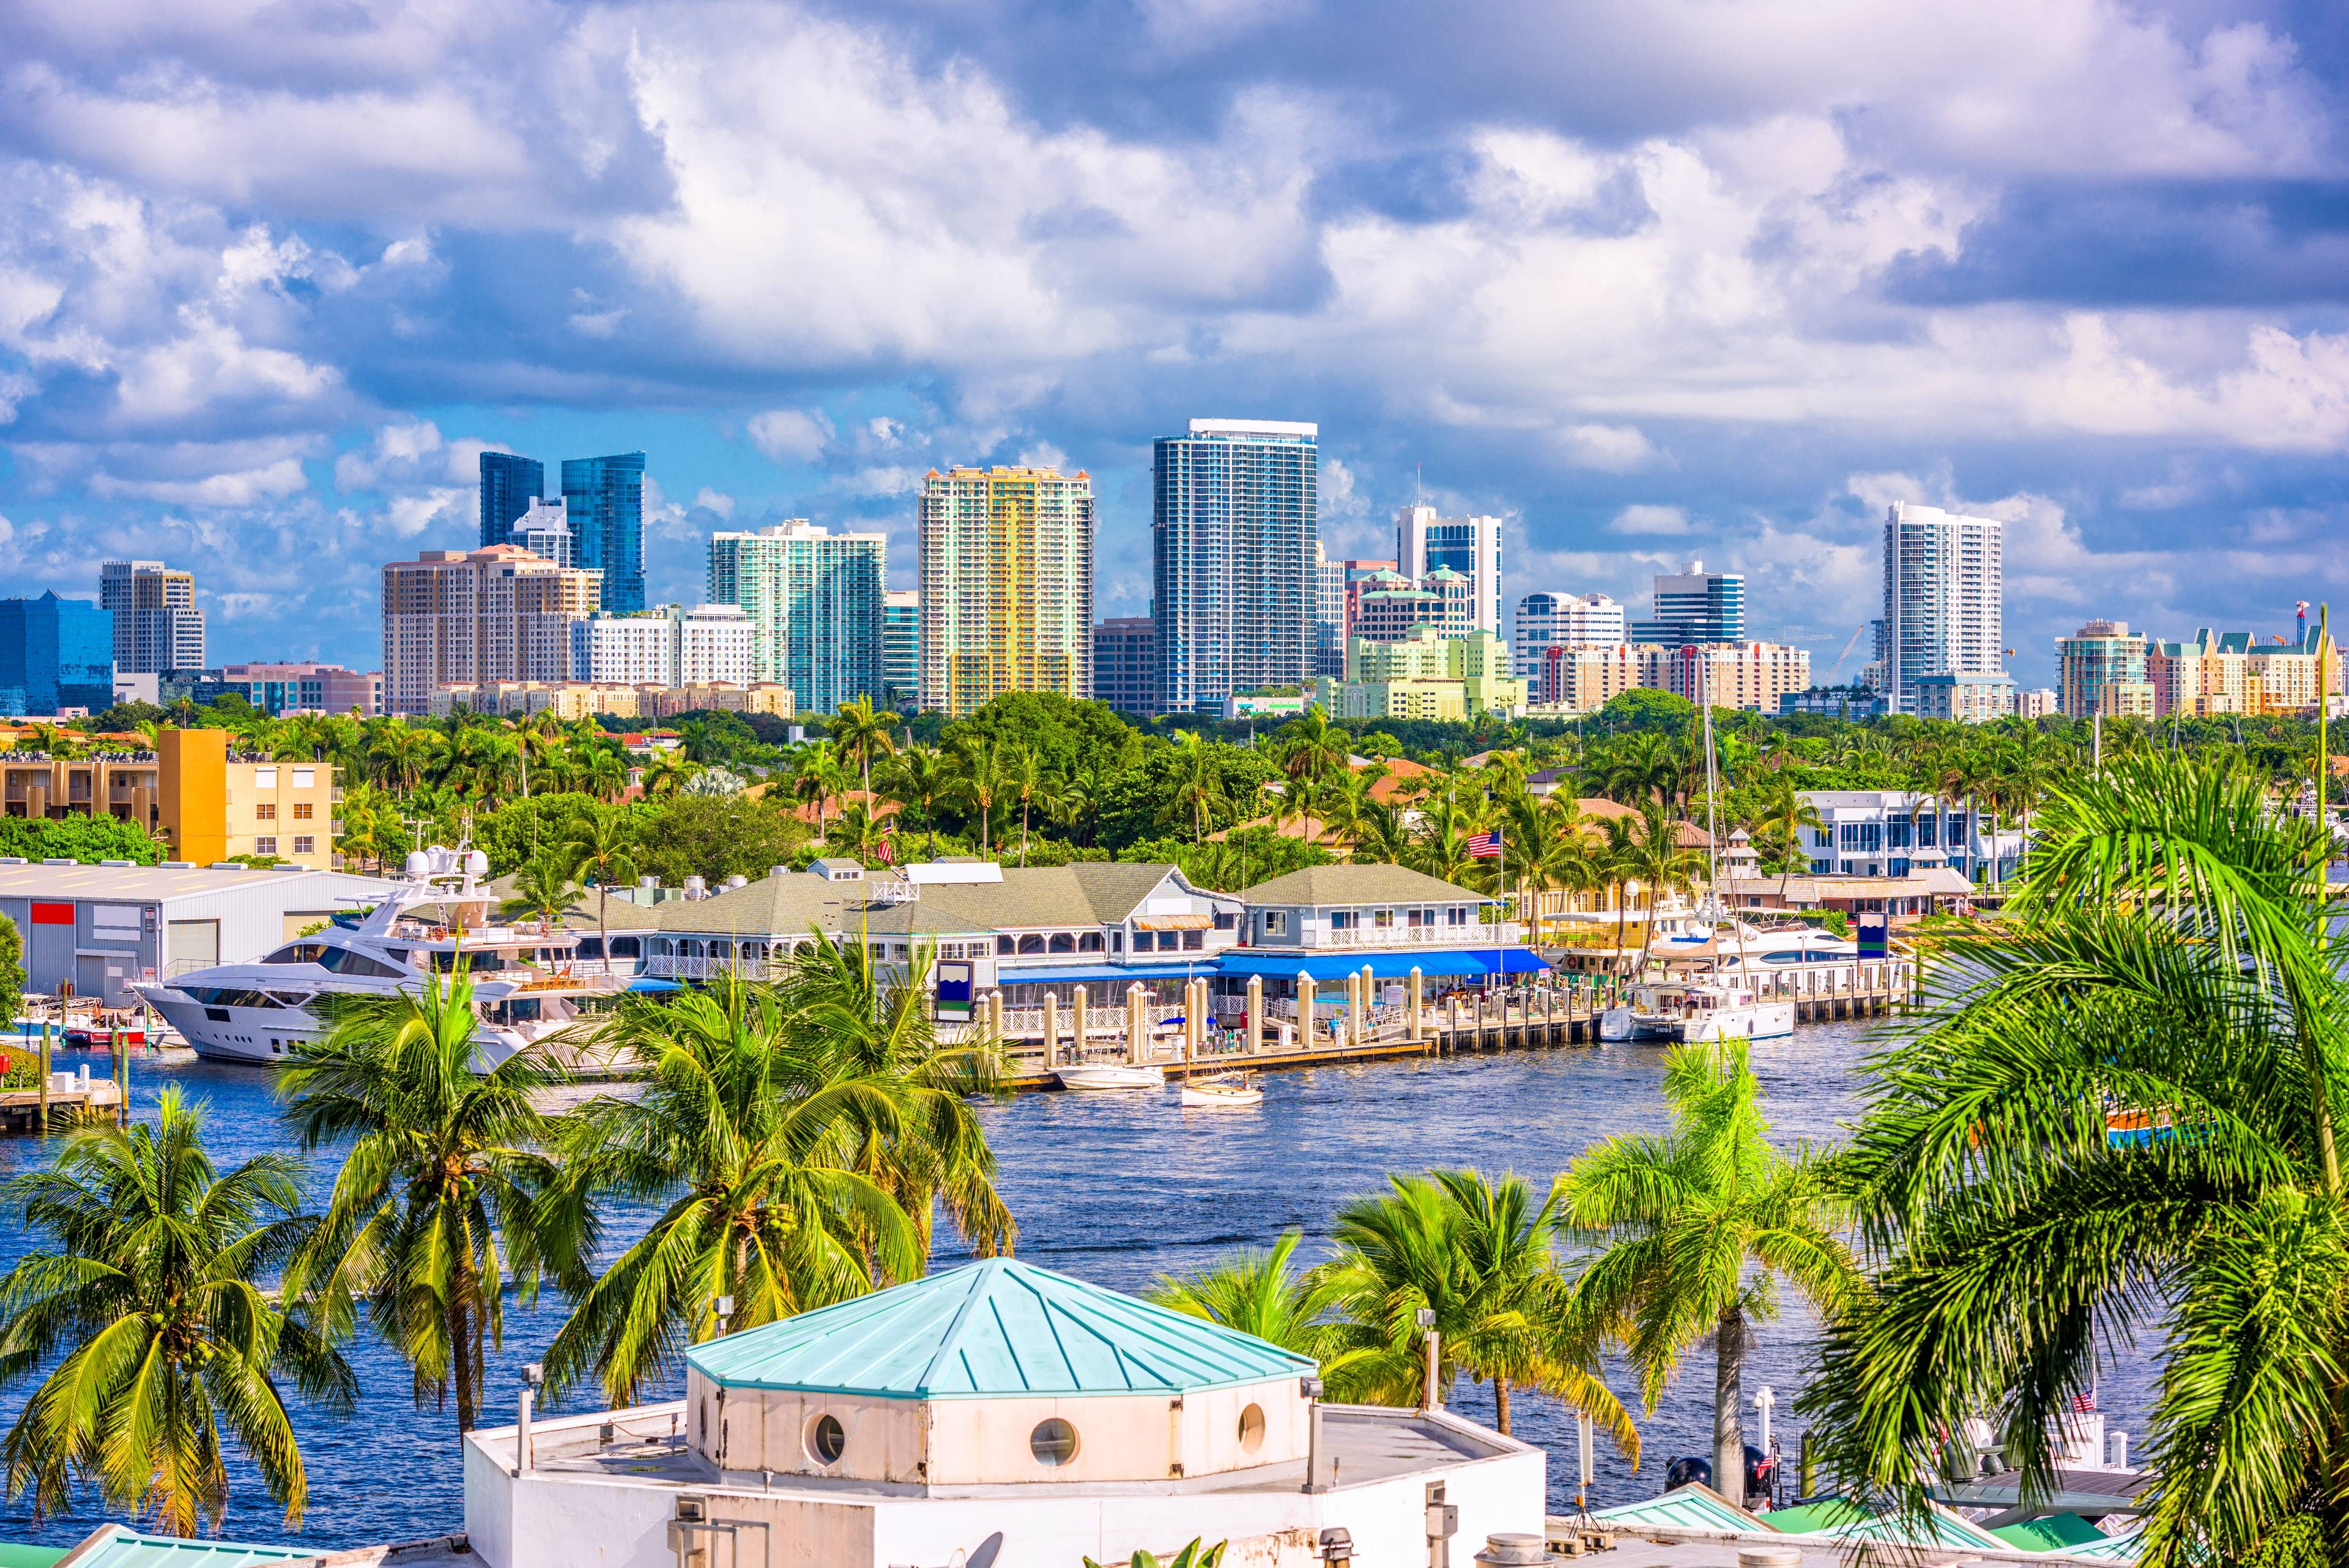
1151;418;1320;712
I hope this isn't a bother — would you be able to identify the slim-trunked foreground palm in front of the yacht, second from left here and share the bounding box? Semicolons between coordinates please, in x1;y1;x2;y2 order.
277;966;563;1432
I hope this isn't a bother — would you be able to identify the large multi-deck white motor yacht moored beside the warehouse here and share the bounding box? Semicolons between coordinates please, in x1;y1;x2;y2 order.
134;846;629;1072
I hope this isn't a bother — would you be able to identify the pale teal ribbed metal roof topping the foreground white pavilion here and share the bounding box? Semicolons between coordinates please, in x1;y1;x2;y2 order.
686;1258;1315;1399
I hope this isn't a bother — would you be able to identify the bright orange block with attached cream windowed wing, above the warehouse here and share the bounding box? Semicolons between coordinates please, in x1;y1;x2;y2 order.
157;729;341;870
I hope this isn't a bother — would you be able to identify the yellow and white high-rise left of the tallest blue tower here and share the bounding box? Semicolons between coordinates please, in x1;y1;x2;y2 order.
921;468;1093;715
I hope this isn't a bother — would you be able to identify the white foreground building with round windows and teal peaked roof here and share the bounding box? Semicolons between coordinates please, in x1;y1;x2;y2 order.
465;1258;1546;1568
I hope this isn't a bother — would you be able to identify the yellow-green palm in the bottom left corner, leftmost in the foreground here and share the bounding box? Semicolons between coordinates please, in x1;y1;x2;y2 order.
0;1086;360;1535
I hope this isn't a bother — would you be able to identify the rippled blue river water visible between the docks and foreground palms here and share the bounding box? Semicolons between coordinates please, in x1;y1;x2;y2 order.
0;1025;2151;1549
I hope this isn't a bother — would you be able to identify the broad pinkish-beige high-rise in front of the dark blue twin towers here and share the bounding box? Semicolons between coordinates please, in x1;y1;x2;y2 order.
383;543;596;715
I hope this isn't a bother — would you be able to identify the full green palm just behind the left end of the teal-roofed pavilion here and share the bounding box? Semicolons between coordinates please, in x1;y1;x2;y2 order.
547;971;923;1406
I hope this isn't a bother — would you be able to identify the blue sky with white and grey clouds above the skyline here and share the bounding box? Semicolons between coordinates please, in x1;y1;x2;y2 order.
0;0;2349;686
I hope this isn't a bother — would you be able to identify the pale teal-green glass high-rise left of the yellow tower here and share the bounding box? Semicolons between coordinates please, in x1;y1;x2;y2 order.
707;517;888;715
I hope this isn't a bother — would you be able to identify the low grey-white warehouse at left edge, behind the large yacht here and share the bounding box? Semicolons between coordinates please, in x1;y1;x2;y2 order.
0;856;392;1006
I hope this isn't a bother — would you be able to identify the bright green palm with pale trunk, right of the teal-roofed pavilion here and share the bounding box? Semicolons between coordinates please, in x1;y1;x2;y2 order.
1553;1039;1860;1502
